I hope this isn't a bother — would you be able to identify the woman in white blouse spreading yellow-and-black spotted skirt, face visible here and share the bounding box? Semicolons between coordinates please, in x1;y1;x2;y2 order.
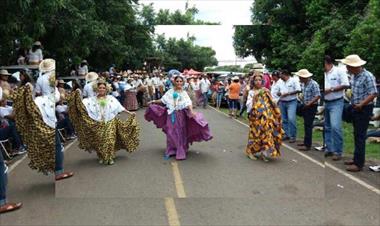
68;79;140;165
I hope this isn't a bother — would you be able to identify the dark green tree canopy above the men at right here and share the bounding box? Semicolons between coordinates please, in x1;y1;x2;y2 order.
234;0;380;81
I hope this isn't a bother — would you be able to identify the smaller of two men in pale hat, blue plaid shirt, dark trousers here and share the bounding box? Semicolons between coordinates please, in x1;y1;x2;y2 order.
295;69;321;151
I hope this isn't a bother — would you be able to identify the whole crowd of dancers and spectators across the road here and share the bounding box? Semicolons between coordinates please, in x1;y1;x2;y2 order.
0;50;380;213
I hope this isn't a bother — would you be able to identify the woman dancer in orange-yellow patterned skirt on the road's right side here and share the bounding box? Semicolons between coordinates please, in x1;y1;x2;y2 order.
246;73;283;162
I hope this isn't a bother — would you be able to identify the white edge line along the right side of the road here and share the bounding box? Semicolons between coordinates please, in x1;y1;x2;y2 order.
209;106;380;195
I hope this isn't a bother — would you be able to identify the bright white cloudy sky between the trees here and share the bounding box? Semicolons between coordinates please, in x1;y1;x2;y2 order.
140;0;255;65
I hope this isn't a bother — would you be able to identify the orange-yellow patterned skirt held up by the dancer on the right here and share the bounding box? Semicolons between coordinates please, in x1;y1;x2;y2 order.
246;92;284;158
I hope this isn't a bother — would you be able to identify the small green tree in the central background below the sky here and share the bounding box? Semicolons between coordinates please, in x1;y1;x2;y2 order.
151;35;218;71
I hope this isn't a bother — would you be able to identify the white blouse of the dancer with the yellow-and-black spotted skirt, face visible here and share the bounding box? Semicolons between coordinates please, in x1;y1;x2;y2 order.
82;95;125;122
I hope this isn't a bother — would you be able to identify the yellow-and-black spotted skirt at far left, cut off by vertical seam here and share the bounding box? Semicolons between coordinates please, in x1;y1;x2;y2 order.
12;86;55;174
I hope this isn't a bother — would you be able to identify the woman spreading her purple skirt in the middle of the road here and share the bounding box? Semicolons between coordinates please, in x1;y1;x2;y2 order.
145;70;212;160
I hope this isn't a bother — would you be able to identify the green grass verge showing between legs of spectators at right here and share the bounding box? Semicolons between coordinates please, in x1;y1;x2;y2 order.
215;108;380;160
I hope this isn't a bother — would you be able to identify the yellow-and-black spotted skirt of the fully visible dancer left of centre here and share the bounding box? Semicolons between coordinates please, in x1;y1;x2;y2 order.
68;90;140;161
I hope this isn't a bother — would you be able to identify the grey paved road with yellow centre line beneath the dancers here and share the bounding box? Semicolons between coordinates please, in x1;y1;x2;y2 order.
0;109;380;225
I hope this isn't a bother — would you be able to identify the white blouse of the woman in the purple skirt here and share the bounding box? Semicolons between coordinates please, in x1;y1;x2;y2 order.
161;89;192;115
